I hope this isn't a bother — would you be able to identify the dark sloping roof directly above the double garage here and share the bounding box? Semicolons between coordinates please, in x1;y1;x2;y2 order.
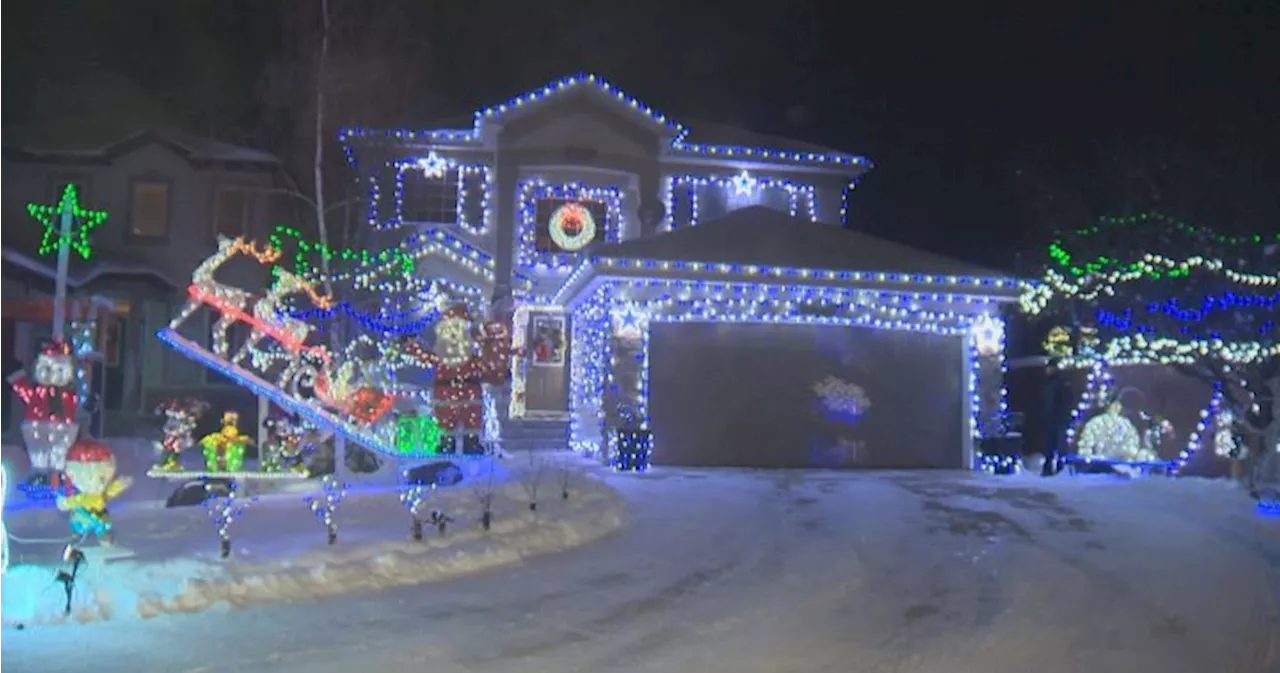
590;206;1006;278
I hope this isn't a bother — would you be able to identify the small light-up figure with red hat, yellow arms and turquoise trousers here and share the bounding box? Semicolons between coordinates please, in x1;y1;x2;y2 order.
58;439;132;545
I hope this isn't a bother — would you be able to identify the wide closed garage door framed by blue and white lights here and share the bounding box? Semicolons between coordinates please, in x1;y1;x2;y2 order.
649;322;969;468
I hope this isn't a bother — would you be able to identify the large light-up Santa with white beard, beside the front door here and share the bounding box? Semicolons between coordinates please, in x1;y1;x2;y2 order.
404;306;511;445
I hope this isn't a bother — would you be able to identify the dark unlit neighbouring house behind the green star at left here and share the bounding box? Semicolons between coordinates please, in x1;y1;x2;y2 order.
0;122;279;432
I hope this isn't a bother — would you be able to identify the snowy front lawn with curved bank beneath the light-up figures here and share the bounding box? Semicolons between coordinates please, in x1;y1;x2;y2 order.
0;445;623;626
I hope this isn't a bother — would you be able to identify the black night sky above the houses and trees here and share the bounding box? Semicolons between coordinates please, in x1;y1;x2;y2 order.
0;0;1280;266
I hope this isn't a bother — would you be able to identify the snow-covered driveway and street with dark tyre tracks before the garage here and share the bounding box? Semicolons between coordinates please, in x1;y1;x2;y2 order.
0;470;1280;673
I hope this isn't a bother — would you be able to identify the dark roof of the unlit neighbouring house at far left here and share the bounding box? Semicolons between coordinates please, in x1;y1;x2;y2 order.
0;119;279;164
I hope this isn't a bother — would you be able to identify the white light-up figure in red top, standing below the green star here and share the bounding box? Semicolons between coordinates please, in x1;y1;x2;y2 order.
9;339;79;480
